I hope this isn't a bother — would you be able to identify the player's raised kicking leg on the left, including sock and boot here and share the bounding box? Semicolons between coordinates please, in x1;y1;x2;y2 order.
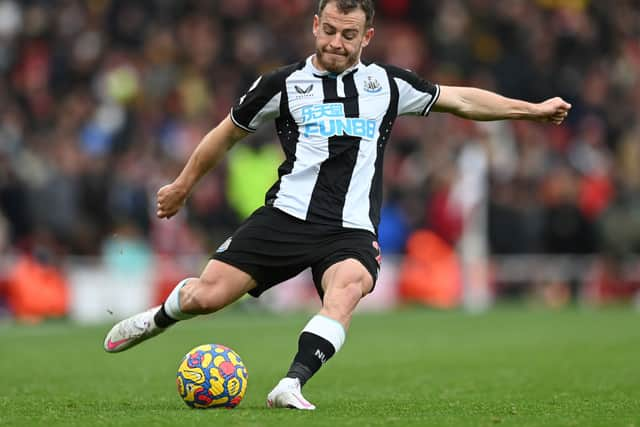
104;260;256;353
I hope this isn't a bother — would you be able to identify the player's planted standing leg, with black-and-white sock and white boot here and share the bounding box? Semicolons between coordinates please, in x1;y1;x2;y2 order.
267;259;374;409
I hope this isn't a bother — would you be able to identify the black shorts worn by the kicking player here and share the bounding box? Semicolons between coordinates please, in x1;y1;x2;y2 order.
212;206;380;298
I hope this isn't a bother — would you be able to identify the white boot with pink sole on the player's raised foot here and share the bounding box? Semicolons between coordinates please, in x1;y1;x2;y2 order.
104;306;166;353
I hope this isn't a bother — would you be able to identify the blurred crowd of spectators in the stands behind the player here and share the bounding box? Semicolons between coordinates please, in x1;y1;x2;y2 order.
0;0;640;308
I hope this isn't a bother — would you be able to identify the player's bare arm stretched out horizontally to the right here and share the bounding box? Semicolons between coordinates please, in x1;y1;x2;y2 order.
433;86;571;125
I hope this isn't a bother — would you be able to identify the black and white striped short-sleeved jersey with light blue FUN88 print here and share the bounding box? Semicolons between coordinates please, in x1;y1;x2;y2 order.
231;57;440;234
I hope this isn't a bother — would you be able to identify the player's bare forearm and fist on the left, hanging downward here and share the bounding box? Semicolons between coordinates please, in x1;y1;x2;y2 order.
156;116;248;218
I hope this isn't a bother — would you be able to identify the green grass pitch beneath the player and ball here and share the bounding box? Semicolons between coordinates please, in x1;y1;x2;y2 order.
0;306;640;427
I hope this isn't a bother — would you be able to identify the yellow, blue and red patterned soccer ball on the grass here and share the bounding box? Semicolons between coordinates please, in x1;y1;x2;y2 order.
176;344;249;409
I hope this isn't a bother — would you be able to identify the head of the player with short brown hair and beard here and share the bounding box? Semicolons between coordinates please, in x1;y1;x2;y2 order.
313;3;373;73
